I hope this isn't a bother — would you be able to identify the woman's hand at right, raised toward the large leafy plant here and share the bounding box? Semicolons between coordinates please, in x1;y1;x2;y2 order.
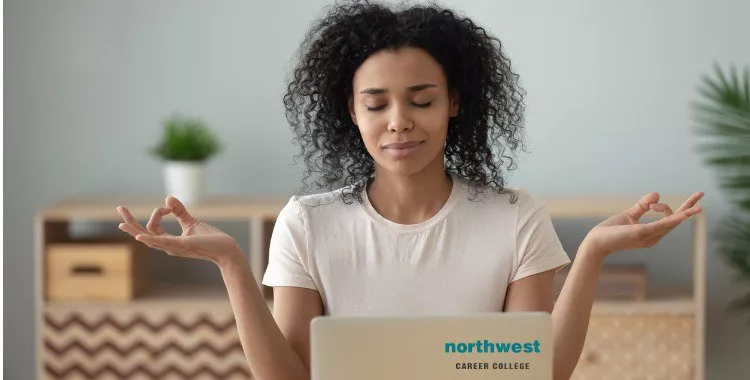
582;192;703;260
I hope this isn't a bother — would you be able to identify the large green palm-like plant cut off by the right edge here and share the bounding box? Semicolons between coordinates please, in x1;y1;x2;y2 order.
694;65;750;323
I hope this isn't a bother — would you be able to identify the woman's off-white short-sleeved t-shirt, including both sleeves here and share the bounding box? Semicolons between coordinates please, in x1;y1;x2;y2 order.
262;176;570;316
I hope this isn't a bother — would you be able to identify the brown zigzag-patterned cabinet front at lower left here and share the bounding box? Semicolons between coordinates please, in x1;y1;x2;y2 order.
44;309;252;379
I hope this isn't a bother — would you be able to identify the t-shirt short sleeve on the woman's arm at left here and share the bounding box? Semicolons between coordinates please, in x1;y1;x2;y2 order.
261;196;317;290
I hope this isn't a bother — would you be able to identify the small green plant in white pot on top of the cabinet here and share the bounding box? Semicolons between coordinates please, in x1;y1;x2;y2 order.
151;114;222;205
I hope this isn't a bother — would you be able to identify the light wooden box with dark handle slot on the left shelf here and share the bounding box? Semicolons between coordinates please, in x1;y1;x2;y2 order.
46;240;148;300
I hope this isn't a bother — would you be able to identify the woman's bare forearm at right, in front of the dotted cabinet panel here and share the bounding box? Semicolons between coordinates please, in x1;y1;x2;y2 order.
552;244;604;380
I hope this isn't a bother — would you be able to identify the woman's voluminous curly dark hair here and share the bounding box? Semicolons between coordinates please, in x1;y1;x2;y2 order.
284;1;526;203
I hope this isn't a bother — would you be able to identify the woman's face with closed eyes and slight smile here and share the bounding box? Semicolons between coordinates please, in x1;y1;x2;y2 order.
349;47;458;175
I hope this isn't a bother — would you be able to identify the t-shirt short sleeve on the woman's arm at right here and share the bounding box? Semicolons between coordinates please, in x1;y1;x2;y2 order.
510;190;571;282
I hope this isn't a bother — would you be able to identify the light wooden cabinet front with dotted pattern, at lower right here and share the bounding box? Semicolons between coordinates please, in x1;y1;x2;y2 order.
572;315;695;380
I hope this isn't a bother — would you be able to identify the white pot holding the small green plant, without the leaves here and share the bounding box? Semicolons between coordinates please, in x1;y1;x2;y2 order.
164;161;205;206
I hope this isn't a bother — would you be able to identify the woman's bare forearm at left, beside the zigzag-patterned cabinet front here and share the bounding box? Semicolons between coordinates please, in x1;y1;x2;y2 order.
219;251;310;380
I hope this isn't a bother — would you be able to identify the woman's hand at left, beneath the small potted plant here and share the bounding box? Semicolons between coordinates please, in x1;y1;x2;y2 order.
117;196;242;265
